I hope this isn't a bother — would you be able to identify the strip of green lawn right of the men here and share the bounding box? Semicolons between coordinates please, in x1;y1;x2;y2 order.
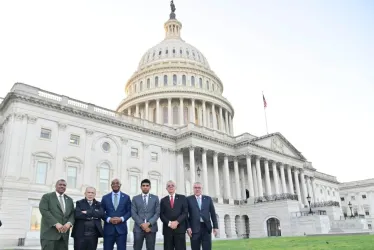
213;235;374;250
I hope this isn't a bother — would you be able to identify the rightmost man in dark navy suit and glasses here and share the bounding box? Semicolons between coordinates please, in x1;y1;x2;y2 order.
187;182;218;250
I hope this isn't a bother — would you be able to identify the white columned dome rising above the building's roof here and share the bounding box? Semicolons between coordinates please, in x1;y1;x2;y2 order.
117;3;234;135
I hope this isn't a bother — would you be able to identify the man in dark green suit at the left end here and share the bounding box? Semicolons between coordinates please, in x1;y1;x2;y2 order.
39;179;74;250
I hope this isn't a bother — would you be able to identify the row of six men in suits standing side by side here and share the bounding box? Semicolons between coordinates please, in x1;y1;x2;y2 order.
39;179;218;250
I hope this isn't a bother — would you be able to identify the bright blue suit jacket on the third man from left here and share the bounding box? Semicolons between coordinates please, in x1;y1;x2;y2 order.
101;192;131;236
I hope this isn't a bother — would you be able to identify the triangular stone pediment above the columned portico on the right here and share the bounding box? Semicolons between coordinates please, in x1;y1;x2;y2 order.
251;133;306;160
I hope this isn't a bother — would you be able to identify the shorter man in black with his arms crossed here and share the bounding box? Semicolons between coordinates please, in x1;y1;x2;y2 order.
71;187;104;250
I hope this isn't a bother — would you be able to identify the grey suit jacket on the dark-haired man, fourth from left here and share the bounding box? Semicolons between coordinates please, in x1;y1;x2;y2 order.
131;194;160;232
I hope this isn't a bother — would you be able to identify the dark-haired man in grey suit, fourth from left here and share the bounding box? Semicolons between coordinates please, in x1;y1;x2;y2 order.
131;179;160;250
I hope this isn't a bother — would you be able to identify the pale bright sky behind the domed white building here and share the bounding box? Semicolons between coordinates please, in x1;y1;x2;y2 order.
0;0;374;182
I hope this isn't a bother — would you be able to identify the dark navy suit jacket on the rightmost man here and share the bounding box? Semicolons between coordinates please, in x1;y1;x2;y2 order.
187;195;218;233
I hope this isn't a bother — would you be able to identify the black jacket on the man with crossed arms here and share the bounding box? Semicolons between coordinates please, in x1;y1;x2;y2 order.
71;199;104;238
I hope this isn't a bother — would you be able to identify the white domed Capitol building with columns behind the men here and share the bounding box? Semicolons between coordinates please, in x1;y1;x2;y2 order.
0;2;374;246
